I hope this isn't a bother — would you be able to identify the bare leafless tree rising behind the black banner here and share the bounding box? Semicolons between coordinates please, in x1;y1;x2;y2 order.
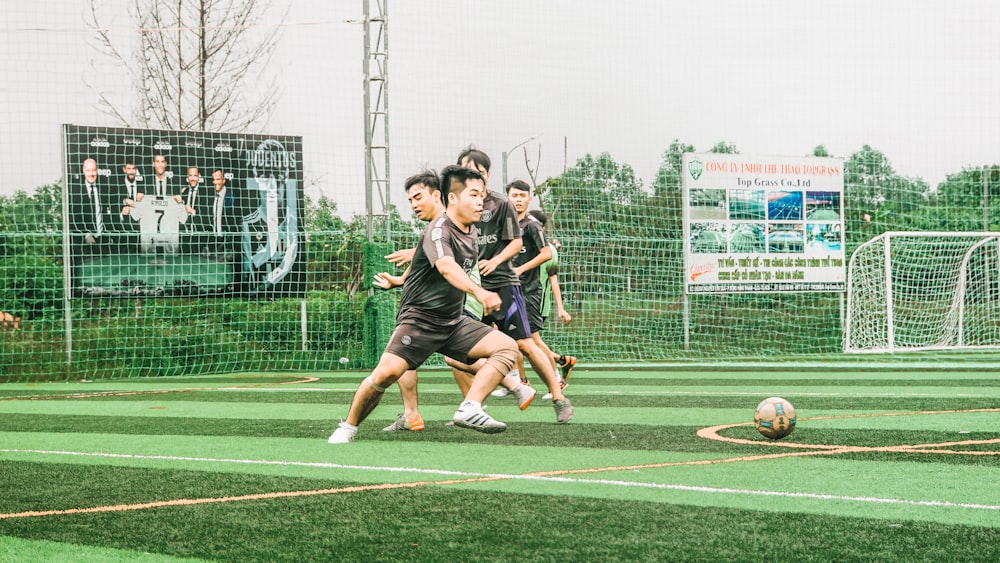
88;0;287;131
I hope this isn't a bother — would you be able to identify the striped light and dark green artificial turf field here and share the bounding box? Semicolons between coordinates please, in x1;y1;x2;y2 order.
0;361;1000;563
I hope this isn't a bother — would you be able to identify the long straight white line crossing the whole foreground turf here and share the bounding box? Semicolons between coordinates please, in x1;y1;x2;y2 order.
0;448;1000;518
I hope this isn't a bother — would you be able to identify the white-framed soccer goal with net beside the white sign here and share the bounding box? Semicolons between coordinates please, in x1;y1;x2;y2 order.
844;232;1000;352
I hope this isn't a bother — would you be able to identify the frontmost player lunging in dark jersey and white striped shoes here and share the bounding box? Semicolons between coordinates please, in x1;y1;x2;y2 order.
328;166;517;444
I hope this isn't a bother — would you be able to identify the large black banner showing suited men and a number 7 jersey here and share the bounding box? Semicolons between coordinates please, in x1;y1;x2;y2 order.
63;125;306;297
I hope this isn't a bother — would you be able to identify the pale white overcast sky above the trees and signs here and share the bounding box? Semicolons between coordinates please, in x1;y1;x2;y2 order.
0;0;1000;216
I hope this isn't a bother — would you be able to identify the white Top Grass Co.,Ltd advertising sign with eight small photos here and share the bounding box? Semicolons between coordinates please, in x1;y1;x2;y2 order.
682;153;846;293
